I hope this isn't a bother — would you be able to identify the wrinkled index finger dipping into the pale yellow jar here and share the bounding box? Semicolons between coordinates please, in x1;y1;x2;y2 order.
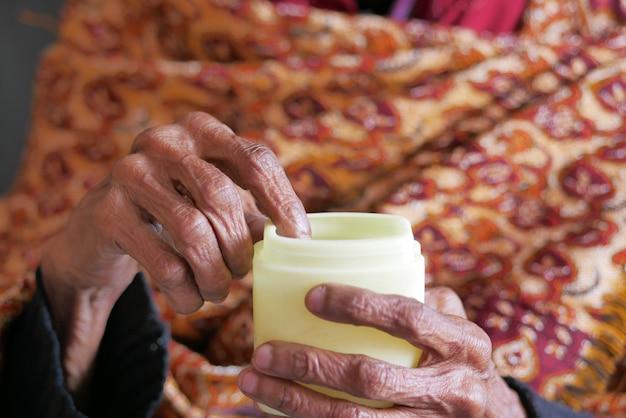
179;112;311;238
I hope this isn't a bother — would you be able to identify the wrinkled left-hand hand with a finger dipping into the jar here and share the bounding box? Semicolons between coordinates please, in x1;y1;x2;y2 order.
41;113;310;396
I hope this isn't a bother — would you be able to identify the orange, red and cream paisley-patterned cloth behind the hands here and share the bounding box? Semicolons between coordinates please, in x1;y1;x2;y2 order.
0;0;626;417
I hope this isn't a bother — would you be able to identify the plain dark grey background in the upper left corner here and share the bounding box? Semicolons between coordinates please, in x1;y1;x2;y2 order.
0;0;63;194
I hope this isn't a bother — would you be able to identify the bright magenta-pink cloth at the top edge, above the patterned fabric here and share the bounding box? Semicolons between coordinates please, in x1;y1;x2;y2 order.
272;0;526;33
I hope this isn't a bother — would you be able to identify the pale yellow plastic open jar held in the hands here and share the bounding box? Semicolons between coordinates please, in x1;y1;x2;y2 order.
252;212;424;413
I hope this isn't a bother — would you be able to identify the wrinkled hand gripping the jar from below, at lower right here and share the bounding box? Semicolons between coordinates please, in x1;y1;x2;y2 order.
239;284;526;418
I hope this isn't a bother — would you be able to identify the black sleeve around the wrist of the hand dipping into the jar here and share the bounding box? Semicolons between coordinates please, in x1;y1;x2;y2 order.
0;272;169;418
